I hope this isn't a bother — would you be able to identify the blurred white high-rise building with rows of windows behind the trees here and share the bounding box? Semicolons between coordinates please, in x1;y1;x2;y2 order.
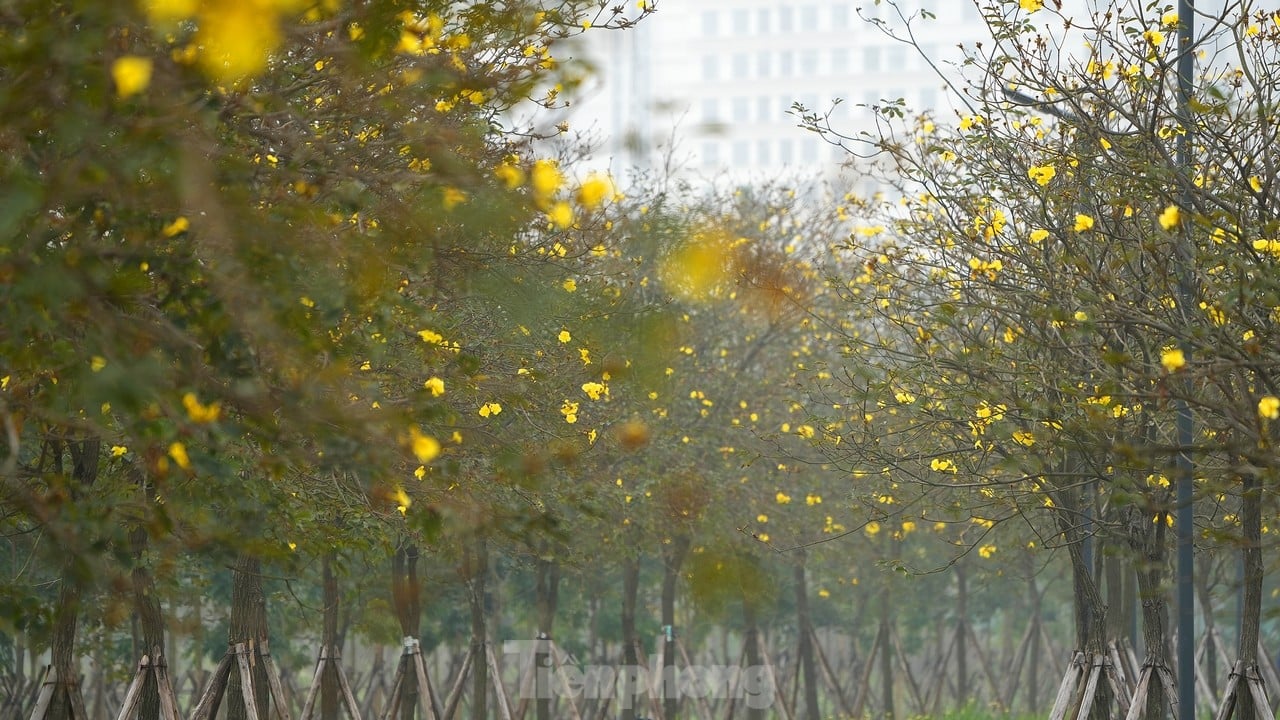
570;0;988;177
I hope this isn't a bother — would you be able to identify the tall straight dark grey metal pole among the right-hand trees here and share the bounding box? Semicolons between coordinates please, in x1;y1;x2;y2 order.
1174;0;1196;720
